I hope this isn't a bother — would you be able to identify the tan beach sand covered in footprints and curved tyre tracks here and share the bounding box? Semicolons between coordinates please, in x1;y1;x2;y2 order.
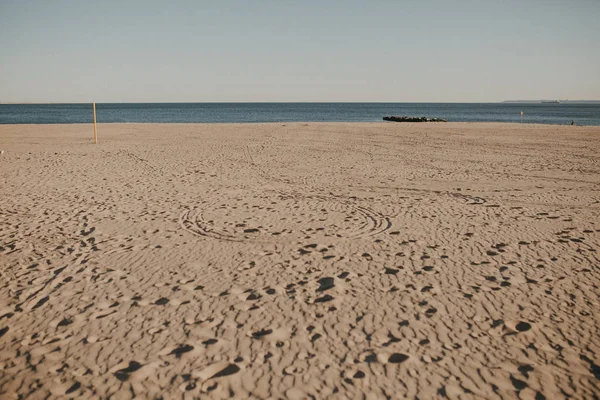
0;123;600;399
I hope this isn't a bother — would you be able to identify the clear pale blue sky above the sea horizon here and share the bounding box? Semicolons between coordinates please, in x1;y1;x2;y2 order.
0;0;600;102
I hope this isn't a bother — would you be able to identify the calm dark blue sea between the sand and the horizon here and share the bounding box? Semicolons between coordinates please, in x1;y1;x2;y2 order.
0;103;600;125
